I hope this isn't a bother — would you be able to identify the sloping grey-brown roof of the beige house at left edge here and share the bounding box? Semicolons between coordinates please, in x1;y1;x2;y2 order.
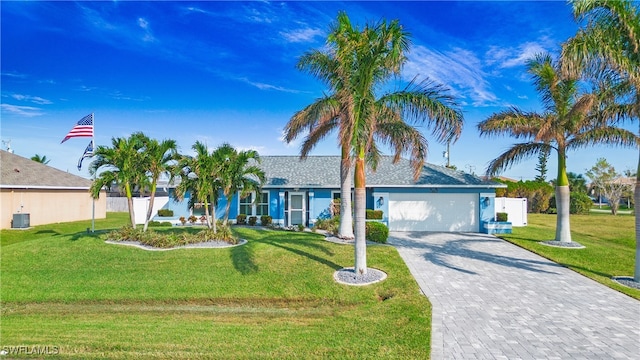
0;150;91;190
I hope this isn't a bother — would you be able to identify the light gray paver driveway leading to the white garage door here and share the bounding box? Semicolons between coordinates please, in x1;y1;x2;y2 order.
389;232;640;360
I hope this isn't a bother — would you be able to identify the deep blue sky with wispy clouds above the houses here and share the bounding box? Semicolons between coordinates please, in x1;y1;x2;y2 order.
0;1;638;180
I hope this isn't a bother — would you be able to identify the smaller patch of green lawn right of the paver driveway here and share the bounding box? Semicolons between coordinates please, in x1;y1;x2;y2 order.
500;213;640;300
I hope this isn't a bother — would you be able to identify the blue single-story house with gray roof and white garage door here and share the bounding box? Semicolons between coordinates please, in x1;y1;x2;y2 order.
155;156;505;232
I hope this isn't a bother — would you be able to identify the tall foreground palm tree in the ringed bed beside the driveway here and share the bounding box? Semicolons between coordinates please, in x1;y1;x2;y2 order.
292;13;462;274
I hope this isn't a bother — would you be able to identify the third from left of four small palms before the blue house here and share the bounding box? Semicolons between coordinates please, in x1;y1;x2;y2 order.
174;141;221;233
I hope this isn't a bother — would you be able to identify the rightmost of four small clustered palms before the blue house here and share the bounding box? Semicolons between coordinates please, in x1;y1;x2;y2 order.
213;144;265;225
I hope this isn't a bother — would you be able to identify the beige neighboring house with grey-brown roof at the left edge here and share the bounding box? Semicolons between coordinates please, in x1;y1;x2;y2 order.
0;150;107;229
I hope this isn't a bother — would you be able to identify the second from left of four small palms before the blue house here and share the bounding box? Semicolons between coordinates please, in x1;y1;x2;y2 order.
133;132;178;231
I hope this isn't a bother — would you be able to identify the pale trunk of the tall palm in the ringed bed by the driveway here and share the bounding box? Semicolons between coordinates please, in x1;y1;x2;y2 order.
354;156;367;275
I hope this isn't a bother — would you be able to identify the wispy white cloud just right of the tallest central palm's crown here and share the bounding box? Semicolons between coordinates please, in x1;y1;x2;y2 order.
404;45;497;106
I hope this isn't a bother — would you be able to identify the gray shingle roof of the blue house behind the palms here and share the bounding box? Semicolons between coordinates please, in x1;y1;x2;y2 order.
259;156;505;188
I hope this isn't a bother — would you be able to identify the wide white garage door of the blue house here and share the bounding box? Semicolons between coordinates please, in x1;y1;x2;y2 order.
389;193;480;232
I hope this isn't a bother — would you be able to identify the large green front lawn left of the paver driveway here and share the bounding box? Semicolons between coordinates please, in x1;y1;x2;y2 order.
0;213;431;359
